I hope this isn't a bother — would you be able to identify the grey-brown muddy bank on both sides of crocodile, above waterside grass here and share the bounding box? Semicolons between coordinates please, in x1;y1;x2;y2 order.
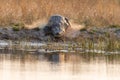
0;27;120;41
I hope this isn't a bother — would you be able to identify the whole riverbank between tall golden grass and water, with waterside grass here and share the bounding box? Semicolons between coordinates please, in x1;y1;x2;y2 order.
0;27;120;53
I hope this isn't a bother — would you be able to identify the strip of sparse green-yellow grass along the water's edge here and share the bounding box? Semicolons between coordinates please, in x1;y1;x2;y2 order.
2;36;120;53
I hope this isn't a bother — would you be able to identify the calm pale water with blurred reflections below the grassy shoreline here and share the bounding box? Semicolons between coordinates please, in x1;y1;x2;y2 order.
0;51;120;80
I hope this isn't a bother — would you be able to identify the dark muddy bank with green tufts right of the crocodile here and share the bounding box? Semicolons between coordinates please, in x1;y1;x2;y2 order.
79;27;120;40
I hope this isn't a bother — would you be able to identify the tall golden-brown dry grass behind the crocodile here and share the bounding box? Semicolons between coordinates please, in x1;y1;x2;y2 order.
0;0;120;26
